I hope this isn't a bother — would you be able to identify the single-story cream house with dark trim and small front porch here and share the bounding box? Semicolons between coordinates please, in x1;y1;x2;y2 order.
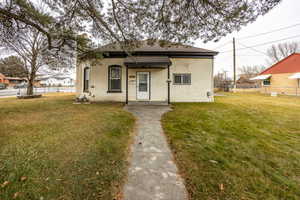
76;41;217;103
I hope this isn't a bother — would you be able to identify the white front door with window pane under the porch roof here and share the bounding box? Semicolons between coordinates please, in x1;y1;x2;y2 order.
136;72;150;100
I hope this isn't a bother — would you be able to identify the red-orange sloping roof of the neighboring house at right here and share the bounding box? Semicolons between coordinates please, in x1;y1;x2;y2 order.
260;53;300;75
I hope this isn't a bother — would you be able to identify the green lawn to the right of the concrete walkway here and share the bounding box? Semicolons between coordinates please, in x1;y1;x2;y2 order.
162;94;300;200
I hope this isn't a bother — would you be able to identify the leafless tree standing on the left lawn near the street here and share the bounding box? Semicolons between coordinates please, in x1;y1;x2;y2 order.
0;27;46;95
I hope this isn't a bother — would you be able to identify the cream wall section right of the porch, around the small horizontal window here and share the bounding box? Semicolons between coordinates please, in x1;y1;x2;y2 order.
170;58;213;102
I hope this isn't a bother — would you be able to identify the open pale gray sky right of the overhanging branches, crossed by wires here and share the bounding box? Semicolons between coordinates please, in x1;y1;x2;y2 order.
195;0;300;76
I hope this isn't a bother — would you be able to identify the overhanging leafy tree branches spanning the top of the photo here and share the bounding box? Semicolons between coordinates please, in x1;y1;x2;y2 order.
0;0;281;48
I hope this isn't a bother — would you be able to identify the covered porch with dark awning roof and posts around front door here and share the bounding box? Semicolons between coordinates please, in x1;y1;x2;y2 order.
124;56;172;105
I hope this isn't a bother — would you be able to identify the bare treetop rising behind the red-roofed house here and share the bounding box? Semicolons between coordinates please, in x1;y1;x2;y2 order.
267;42;300;65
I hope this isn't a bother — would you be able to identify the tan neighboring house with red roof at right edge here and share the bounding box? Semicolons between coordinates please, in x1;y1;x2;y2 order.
252;53;300;95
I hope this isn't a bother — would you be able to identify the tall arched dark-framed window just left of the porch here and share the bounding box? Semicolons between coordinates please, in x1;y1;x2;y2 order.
108;65;122;92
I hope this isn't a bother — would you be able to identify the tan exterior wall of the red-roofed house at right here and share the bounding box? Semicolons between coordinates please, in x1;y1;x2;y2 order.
261;73;300;95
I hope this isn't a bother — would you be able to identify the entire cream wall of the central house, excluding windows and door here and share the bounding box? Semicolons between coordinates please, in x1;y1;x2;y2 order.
76;58;213;102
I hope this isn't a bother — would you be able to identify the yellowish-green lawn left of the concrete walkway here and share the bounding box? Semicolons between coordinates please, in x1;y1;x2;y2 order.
0;96;134;200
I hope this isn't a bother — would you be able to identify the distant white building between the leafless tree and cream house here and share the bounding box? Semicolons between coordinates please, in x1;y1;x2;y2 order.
40;75;75;86
